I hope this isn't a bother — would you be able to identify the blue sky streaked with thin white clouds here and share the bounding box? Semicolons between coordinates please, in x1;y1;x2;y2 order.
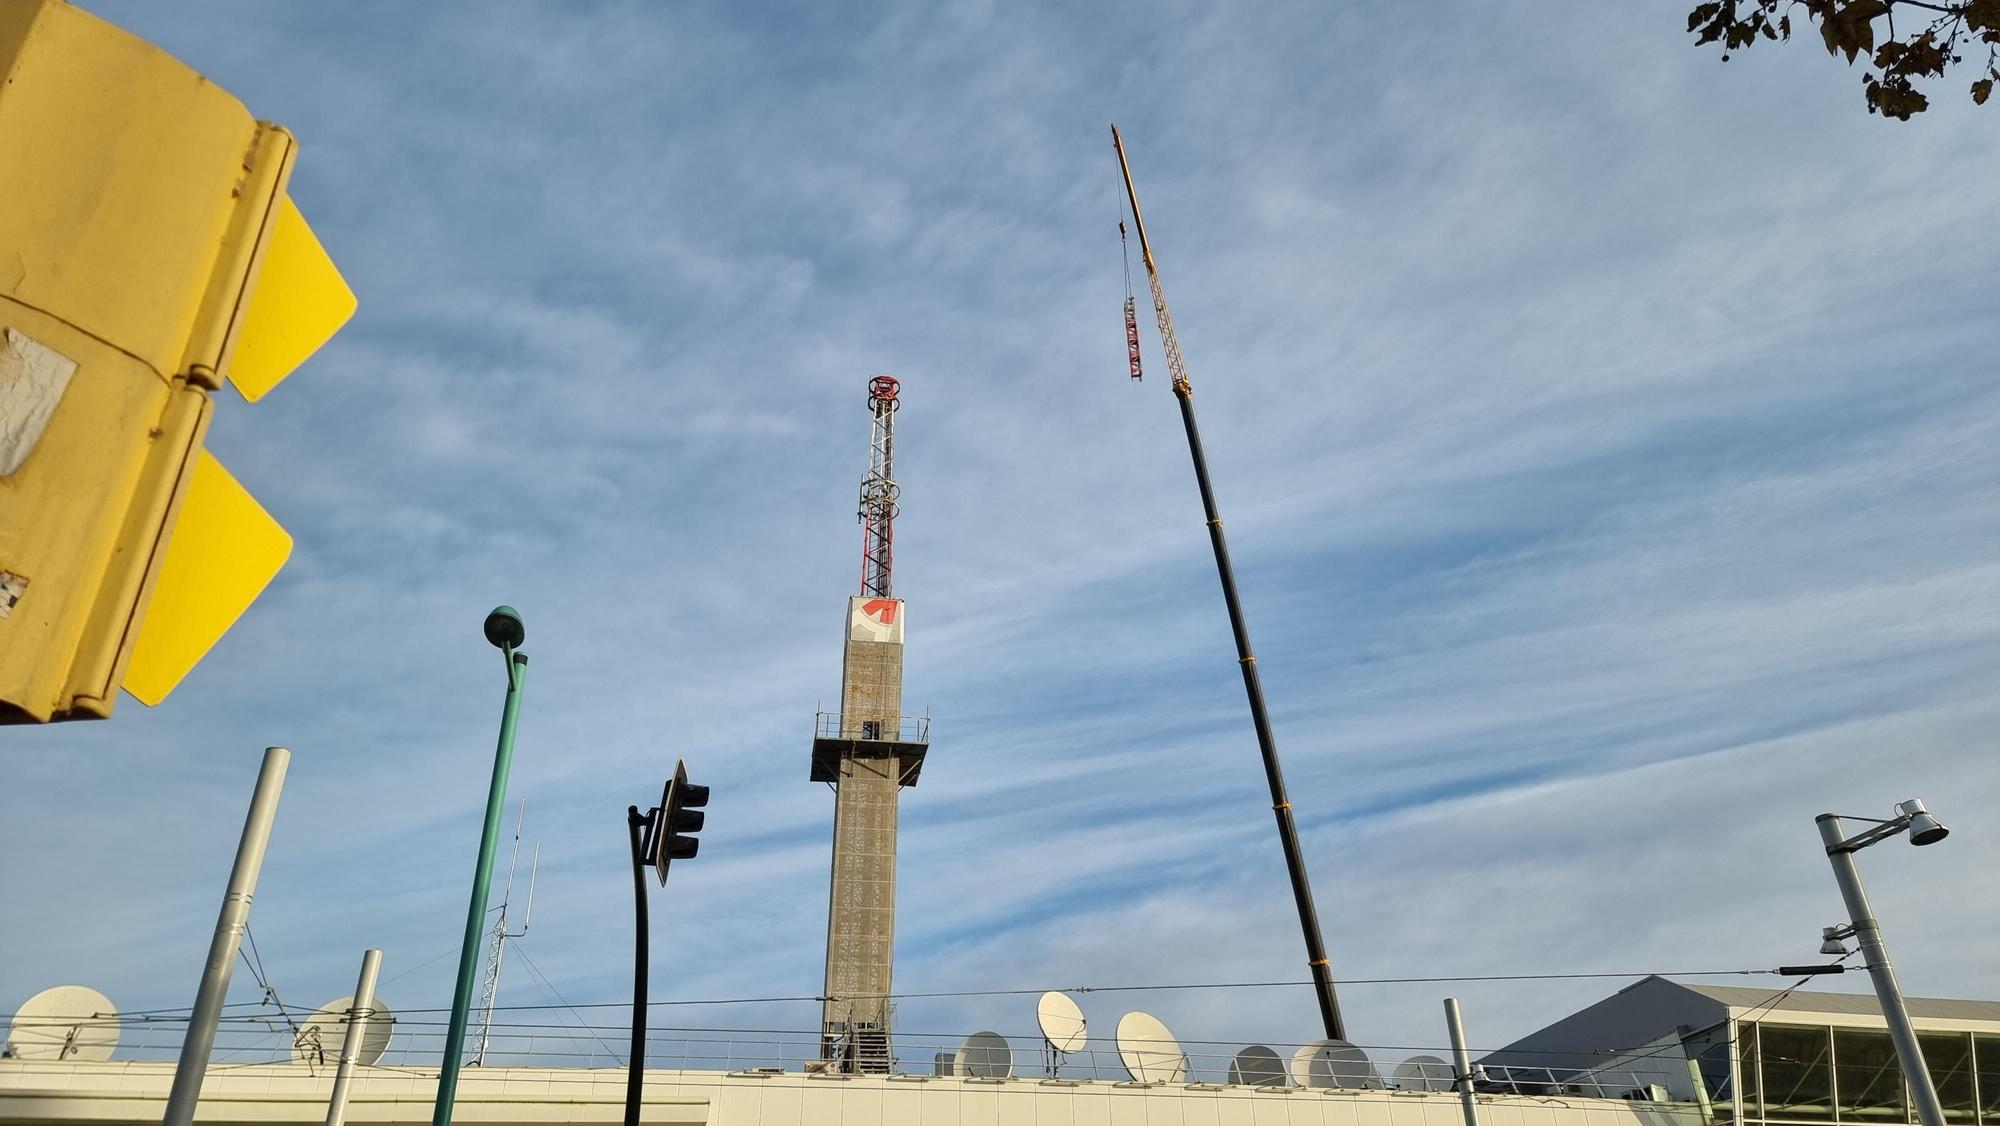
0;2;2000;1062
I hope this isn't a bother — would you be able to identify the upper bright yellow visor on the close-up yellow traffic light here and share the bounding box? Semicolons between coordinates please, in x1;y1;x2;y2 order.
228;196;356;402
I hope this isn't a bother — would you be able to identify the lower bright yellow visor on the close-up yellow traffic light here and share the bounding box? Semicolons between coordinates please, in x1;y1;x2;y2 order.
124;450;292;704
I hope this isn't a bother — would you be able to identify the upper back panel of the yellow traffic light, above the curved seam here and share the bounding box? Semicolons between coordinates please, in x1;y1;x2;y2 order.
0;0;258;380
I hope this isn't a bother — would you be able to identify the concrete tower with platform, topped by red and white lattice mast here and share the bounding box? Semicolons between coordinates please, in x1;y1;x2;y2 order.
812;376;930;1072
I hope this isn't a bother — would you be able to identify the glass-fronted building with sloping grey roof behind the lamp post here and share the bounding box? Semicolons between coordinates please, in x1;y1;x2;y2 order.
1480;978;2000;1126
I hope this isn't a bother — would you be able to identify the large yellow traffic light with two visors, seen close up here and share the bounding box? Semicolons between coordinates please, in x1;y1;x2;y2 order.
0;0;354;722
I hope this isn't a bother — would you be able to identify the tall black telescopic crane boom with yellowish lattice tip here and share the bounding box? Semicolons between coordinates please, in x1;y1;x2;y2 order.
1112;126;1346;1040
